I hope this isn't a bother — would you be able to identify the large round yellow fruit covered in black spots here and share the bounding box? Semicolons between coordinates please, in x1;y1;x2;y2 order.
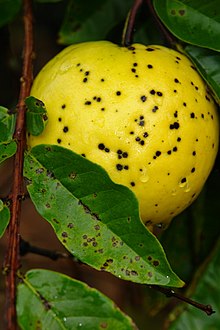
28;41;219;225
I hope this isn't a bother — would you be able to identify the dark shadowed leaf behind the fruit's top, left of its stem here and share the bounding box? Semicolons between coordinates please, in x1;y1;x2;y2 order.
59;0;133;45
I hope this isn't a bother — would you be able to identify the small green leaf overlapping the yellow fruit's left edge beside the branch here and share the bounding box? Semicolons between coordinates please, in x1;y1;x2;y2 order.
25;96;48;136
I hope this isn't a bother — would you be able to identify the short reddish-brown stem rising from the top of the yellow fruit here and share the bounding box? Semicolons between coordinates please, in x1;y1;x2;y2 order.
122;0;143;47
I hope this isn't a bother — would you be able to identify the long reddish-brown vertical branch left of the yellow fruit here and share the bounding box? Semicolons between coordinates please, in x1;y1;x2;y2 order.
4;0;33;330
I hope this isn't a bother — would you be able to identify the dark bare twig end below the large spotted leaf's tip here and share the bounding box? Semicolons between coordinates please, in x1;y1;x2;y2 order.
150;285;215;316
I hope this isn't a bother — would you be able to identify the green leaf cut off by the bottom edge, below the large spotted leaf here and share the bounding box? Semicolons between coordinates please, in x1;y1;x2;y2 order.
17;269;137;330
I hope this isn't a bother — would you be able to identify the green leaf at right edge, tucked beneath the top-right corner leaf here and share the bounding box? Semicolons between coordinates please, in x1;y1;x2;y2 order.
185;44;220;104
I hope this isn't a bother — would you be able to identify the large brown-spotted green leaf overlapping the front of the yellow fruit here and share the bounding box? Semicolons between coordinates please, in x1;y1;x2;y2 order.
24;145;183;287
